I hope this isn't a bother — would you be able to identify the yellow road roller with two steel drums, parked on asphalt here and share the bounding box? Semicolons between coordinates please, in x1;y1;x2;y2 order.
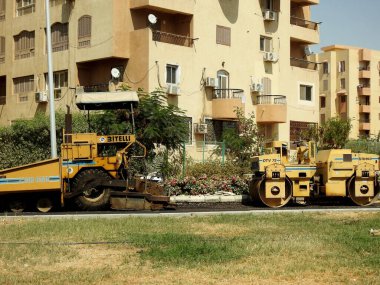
249;141;380;208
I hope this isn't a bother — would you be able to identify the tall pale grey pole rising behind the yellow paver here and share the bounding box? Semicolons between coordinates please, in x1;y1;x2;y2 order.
45;0;57;158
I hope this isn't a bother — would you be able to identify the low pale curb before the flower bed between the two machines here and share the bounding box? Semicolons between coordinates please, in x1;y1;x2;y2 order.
170;195;250;203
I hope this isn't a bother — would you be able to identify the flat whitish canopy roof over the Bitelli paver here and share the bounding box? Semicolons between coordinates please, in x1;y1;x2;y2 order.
76;91;139;110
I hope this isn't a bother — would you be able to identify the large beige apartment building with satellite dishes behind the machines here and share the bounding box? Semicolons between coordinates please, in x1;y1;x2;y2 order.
0;0;320;155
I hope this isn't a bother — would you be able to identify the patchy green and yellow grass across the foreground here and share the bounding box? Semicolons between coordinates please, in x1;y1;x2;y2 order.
0;213;380;284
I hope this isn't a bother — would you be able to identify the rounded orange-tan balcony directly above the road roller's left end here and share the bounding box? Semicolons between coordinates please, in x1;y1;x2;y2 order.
256;95;287;123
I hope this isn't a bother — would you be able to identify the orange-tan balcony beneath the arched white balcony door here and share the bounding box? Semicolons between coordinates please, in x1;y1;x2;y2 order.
212;89;245;120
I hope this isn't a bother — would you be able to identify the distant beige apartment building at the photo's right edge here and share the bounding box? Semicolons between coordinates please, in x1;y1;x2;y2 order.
317;45;380;139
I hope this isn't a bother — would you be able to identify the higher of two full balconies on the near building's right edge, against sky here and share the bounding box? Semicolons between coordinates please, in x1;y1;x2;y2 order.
290;16;320;44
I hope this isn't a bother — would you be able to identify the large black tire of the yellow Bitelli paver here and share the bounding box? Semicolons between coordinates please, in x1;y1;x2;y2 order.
72;169;111;211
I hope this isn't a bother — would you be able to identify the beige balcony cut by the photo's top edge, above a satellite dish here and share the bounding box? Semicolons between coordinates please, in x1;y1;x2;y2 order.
130;0;195;14
